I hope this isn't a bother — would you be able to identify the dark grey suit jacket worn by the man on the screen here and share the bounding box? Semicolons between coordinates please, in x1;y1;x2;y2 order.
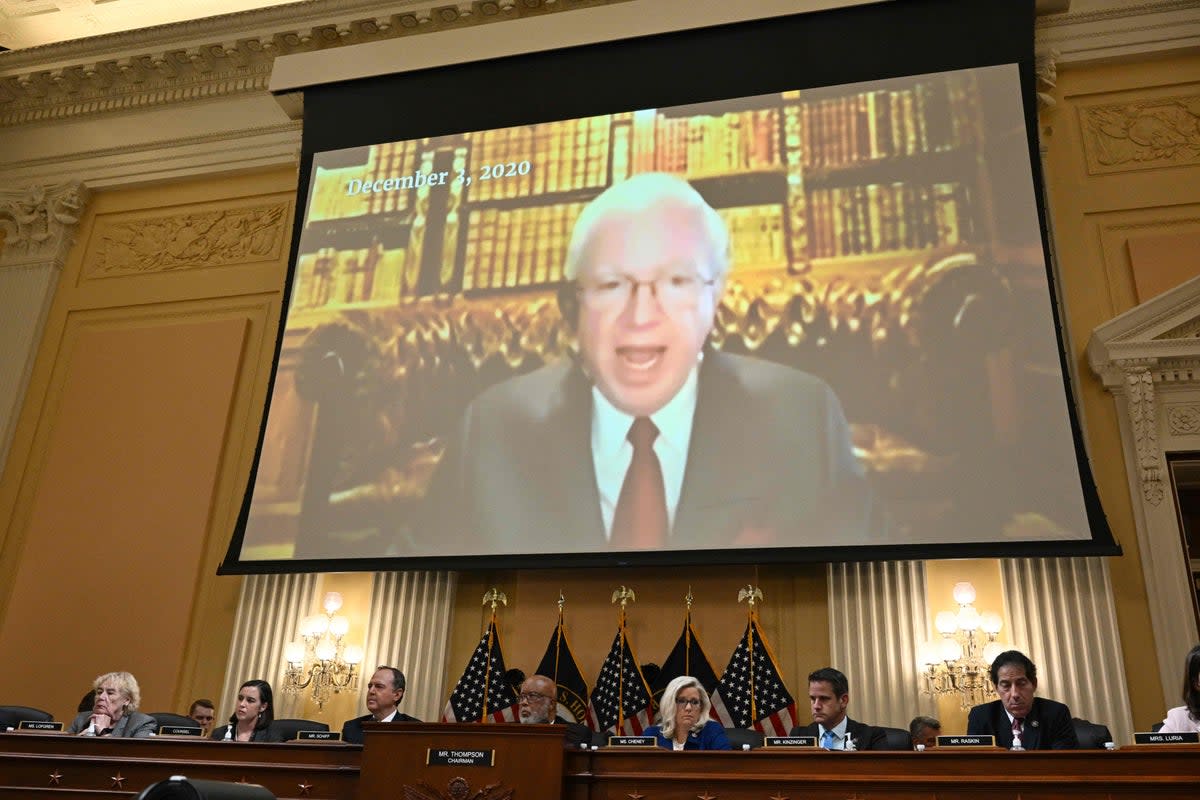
412;351;874;555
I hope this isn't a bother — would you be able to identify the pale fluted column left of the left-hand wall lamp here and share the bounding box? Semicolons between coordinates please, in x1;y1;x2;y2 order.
214;573;318;724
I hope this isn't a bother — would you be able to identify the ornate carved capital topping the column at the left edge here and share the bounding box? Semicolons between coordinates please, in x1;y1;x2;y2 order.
0;181;88;269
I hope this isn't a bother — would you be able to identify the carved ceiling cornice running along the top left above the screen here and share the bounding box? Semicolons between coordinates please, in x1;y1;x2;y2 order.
0;0;628;127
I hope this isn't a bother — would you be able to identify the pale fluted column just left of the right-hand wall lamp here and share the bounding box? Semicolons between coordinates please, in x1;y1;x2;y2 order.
830;561;930;728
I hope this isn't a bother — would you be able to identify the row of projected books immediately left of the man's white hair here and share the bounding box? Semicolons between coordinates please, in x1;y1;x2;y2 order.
462;203;584;291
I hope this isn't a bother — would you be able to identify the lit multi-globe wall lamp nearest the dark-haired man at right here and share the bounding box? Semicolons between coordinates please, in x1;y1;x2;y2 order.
920;581;1004;709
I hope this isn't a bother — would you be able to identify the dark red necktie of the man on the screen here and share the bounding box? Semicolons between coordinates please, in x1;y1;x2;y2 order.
612;416;667;551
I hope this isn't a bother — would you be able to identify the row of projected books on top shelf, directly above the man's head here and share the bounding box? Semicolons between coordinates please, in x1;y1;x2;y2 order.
613;108;782;178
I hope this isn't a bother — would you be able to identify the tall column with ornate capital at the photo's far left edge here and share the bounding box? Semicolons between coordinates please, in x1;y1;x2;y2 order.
0;182;88;470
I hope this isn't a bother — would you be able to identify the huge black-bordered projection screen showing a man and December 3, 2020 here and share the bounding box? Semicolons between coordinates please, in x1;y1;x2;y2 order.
222;0;1118;572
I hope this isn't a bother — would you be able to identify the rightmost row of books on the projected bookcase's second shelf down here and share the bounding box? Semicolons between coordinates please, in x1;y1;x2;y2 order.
809;182;973;258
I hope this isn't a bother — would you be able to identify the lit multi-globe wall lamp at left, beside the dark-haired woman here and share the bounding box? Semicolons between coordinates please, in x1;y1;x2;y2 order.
283;591;362;709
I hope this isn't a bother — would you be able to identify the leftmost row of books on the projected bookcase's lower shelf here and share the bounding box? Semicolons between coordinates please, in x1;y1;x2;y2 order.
292;242;416;309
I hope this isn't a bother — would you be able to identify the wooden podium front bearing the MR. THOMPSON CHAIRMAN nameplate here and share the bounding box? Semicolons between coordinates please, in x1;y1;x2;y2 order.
359;723;566;800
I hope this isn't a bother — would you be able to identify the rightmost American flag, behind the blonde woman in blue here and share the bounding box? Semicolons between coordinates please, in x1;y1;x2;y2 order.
713;610;796;736
